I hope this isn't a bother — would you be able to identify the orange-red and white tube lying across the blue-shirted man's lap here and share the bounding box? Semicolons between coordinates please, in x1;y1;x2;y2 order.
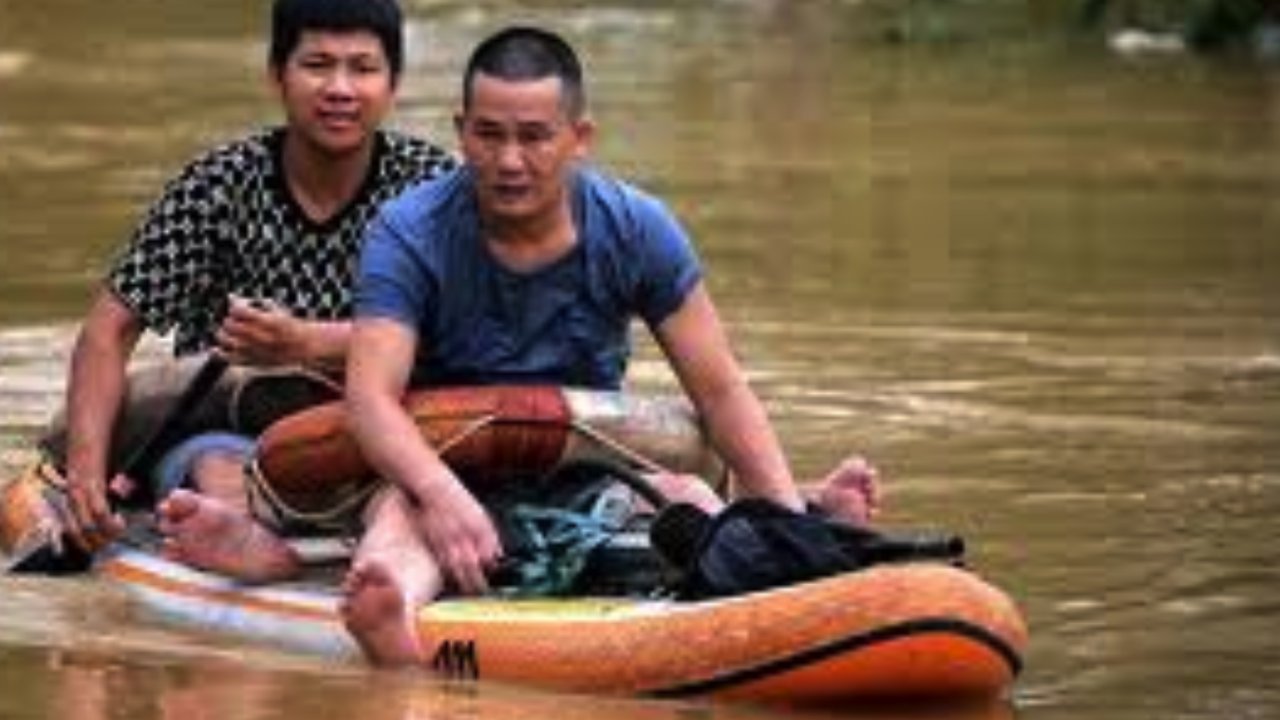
253;386;721;515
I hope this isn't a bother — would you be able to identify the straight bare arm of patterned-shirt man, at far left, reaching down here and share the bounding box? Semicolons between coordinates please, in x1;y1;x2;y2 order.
67;288;142;552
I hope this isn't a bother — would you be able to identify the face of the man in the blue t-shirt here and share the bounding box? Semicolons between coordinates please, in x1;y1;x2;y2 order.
457;73;593;222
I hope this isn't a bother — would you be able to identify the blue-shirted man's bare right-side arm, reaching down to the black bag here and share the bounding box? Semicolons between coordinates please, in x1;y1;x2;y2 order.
655;283;803;510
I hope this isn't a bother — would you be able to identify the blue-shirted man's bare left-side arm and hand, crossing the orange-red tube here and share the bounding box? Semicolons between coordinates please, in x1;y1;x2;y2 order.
346;318;502;593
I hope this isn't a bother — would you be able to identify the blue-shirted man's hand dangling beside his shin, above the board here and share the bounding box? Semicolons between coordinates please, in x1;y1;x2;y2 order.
419;478;502;594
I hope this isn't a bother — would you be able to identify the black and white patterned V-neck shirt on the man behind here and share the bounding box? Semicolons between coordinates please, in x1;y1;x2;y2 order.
108;128;454;355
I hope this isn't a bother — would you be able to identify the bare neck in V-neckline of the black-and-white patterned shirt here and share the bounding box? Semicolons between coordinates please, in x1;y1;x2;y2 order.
282;132;374;223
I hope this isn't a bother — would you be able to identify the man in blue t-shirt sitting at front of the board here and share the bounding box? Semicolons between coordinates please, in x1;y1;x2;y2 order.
342;27;870;664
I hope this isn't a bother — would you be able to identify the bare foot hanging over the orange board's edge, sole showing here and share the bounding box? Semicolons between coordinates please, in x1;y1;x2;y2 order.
338;560;422;666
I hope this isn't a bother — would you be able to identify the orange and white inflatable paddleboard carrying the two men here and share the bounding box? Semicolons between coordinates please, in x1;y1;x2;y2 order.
97;538;1027;705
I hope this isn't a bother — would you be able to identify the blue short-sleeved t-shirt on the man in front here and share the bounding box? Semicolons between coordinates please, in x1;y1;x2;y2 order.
356;168;701;389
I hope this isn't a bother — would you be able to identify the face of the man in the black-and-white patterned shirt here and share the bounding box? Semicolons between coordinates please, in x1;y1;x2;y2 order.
274;31;396;155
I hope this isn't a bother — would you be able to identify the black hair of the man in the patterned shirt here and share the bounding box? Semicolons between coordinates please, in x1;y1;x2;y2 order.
268;0;404;78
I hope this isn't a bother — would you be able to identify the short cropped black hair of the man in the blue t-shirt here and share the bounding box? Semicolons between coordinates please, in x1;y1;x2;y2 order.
462;26;586;119
